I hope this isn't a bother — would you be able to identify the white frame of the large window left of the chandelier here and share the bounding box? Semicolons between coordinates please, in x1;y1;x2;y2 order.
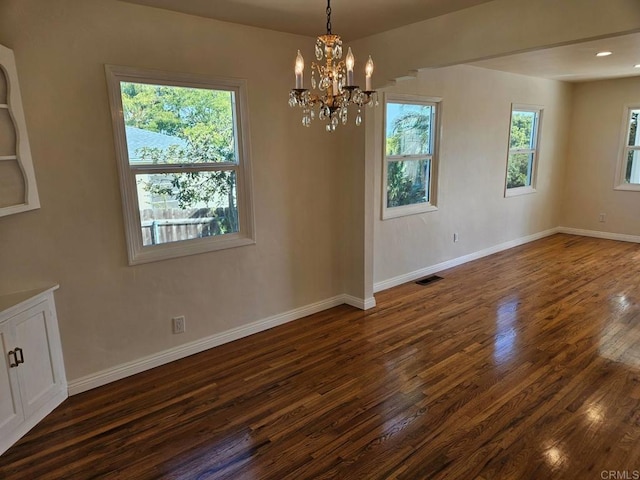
105;65;256;265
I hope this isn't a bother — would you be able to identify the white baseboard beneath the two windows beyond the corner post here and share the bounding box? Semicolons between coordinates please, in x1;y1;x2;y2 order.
373;228;560;293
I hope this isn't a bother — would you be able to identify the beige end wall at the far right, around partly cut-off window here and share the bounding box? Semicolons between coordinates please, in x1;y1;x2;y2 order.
562;77;640;235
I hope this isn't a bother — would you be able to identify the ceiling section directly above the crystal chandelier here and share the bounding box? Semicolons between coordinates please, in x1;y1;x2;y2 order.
123;0;498;40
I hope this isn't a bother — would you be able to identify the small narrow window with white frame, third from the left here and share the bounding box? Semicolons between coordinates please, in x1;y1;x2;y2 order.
505;105;542;197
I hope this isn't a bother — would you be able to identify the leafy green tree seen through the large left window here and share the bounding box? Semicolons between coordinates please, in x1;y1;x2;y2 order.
121;82;238;234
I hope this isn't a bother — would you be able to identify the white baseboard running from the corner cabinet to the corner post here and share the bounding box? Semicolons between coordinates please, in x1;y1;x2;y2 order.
68;295;368;395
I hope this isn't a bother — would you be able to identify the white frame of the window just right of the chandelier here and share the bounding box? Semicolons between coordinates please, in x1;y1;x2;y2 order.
381;93;442;220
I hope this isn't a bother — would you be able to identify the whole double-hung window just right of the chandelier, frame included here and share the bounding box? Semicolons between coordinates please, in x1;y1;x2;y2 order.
382;95;440;219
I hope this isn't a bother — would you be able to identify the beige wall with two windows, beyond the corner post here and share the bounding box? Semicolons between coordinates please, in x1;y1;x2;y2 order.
374;66;571;283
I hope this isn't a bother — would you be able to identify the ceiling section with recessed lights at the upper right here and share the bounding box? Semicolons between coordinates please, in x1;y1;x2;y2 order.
470;33;640;82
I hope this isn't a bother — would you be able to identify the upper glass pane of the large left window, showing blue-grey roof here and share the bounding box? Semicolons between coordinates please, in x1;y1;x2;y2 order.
120;82;237;165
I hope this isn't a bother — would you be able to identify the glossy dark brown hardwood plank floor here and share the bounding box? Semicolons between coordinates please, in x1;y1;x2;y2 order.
0;235;640;480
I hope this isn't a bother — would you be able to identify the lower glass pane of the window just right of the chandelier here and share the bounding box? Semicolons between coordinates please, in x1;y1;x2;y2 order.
387;159;431;208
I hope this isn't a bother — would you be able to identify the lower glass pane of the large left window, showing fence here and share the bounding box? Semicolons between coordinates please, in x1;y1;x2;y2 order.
136;171;239;246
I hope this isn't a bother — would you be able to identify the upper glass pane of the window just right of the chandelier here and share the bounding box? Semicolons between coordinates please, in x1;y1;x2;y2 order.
386;103;435;155
